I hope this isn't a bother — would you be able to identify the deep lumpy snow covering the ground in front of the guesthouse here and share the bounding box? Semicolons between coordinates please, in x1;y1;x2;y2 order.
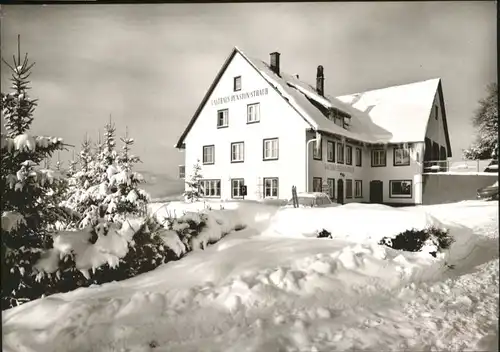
2;201;499;352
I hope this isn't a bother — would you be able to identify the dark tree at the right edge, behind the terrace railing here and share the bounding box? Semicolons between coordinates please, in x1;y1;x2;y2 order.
464;83;498;160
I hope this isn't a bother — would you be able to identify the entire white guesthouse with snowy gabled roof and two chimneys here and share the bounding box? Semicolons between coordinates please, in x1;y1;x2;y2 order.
176;48;451;204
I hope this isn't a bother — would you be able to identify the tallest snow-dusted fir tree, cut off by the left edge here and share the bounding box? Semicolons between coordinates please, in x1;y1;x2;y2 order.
0;38;65;309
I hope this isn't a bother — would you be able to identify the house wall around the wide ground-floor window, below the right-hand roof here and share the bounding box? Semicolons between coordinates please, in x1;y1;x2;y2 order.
365;143;424;204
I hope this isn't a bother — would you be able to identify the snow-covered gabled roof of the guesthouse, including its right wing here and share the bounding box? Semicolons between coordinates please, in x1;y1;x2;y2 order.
176;47;451;154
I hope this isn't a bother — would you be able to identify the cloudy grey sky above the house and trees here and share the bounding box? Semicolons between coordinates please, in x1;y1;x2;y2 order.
1;1;497;177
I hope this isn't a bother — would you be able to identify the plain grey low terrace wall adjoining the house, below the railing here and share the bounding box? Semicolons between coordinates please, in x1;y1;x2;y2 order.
422;173;498;204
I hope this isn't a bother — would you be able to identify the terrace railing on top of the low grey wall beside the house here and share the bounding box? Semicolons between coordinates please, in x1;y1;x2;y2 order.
423;159;498;173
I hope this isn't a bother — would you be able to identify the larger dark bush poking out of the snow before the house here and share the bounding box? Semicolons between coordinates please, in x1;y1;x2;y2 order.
379;226;454;257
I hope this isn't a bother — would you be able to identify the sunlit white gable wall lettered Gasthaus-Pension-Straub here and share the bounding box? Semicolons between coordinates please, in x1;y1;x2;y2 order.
185;53;308;199
